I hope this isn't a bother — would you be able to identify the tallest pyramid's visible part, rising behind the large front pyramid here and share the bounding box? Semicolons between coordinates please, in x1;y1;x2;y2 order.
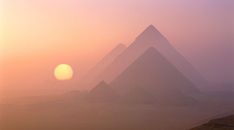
94;25;205;85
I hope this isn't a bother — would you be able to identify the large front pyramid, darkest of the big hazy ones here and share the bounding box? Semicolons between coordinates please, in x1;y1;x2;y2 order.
110;47;199;104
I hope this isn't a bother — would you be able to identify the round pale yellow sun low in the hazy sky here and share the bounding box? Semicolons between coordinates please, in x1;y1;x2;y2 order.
54;64;73;80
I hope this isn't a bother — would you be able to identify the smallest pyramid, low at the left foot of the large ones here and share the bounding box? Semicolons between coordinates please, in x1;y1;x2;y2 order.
87;81;116;102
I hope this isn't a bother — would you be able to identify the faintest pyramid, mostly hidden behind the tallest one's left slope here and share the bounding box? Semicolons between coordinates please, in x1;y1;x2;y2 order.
79;44;126;89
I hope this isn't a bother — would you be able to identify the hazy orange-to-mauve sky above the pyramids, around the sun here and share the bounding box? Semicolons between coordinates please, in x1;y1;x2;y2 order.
0;0;234;99
